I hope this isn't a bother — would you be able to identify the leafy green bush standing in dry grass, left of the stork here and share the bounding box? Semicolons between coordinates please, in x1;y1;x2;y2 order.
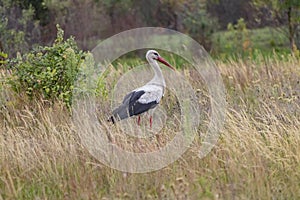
8;26;85;106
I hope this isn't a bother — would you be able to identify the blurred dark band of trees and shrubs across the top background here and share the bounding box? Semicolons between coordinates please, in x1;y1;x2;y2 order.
0;0;300;57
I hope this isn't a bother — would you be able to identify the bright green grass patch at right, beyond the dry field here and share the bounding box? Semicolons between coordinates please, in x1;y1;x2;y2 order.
212;27;290;59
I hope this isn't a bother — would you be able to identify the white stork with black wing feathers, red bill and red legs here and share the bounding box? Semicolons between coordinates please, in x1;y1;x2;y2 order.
108;50;175;128
